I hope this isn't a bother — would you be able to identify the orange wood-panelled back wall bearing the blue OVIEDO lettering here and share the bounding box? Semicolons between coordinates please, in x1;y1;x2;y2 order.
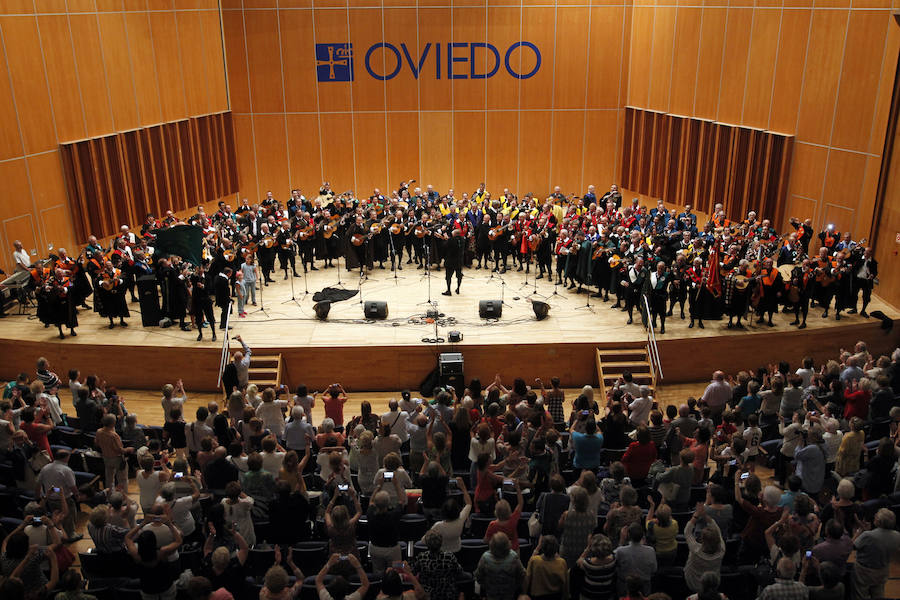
222;0;631;200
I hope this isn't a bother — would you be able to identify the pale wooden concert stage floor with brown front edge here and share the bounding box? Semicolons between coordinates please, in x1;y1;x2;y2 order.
0;265;900;393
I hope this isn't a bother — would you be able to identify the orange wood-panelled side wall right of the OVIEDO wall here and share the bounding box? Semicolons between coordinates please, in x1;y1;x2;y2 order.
627;0;900;246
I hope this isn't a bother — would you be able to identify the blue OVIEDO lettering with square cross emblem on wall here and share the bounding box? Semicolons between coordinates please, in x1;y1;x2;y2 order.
316;41;541;82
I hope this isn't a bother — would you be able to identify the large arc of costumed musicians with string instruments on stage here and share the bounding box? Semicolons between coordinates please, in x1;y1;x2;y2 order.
12;181;878;337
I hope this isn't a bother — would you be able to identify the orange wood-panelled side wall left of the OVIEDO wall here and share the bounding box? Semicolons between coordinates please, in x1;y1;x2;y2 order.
0;0;228;272
